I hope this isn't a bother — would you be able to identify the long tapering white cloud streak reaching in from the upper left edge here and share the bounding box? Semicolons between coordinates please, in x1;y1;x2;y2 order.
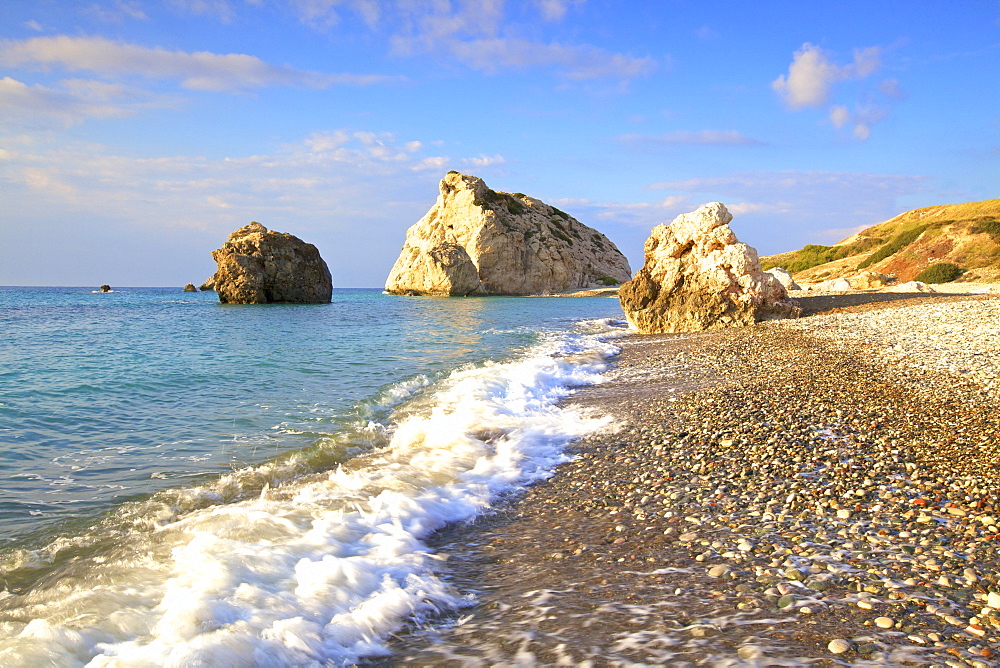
0;36;389;91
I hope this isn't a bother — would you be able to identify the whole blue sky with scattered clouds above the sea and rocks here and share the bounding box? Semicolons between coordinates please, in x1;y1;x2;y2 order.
0;0;1000;287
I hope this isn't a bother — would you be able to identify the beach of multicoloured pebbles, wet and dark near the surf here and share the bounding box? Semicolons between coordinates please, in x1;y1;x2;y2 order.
373;295;1000;666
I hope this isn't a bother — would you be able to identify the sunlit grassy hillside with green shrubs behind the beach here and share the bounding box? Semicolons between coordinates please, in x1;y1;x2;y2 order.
761;199;1000;283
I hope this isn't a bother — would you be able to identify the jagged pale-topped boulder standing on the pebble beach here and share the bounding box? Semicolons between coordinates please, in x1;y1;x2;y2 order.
619;202;799;334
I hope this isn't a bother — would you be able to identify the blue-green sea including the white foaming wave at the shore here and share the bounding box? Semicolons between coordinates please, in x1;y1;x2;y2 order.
0;287;627;666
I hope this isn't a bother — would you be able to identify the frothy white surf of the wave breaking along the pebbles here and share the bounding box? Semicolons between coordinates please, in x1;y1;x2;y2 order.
0;321;615;666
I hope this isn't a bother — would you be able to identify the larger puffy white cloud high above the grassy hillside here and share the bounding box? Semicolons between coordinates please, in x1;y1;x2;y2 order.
771;42;881;109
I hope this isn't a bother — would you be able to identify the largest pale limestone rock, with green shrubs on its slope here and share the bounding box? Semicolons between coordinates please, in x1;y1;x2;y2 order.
385;172;631;296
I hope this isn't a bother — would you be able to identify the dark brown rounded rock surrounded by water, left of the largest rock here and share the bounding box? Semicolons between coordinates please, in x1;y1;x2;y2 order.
212;222;333;304
